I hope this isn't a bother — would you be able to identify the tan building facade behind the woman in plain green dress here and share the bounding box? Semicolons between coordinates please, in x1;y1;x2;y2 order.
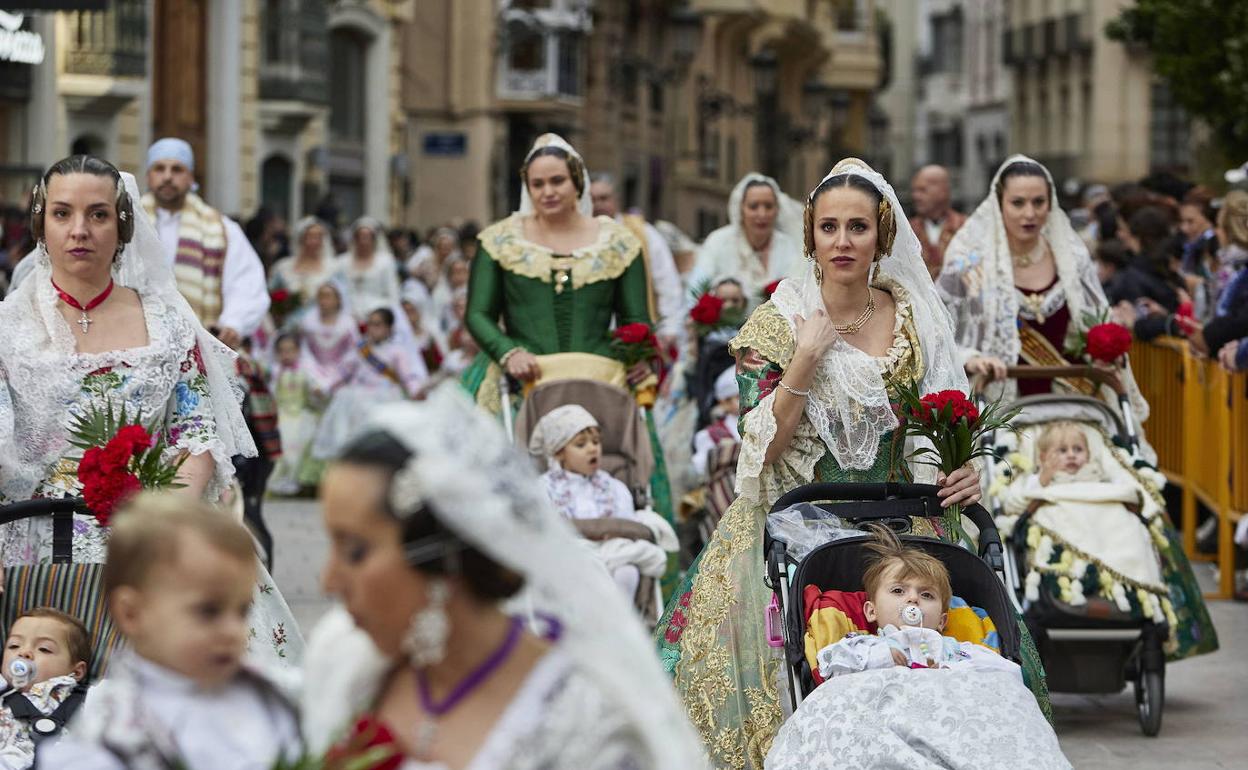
403;0;881;235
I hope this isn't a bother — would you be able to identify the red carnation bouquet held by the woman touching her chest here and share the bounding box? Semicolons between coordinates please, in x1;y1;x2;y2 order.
896;383;1018;543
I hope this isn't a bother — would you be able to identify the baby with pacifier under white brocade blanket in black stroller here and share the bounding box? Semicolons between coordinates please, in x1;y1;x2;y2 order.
765;528;1071;770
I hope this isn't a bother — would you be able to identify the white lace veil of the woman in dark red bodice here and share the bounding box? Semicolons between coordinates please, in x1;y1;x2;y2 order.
937;155;1148;424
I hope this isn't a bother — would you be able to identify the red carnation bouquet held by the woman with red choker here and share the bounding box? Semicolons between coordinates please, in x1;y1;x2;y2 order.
70;402;182;527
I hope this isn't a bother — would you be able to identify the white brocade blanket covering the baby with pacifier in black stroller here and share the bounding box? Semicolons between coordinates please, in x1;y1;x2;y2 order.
764;666;1071;770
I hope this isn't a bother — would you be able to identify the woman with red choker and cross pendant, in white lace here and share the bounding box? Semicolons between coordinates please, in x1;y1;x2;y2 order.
0;155;302;664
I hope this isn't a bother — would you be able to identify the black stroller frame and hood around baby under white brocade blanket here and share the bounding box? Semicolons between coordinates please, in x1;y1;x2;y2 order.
763;483;1021;710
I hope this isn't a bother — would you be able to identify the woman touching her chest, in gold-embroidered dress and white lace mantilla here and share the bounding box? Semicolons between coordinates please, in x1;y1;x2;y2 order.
656;158;1023;769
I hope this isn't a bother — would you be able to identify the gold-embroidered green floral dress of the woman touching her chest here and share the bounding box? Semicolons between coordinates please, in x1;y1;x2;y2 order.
655;282;1047;770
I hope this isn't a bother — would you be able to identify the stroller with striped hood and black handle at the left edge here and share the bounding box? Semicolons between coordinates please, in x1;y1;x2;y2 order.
0;498;121;681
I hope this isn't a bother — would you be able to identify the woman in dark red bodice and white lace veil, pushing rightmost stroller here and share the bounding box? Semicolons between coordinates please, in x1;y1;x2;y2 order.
936;155;1153;441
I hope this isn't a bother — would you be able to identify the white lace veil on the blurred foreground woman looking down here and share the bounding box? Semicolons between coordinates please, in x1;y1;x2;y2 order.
367;383;703;770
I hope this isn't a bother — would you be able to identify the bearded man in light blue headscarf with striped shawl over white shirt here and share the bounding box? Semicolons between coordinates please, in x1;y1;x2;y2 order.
142;137;268;349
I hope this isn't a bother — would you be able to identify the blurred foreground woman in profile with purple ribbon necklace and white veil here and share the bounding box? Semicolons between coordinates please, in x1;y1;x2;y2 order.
303;383;700;770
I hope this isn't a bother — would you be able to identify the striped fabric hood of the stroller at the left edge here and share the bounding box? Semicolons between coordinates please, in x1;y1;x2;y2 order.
0;564;121;681
